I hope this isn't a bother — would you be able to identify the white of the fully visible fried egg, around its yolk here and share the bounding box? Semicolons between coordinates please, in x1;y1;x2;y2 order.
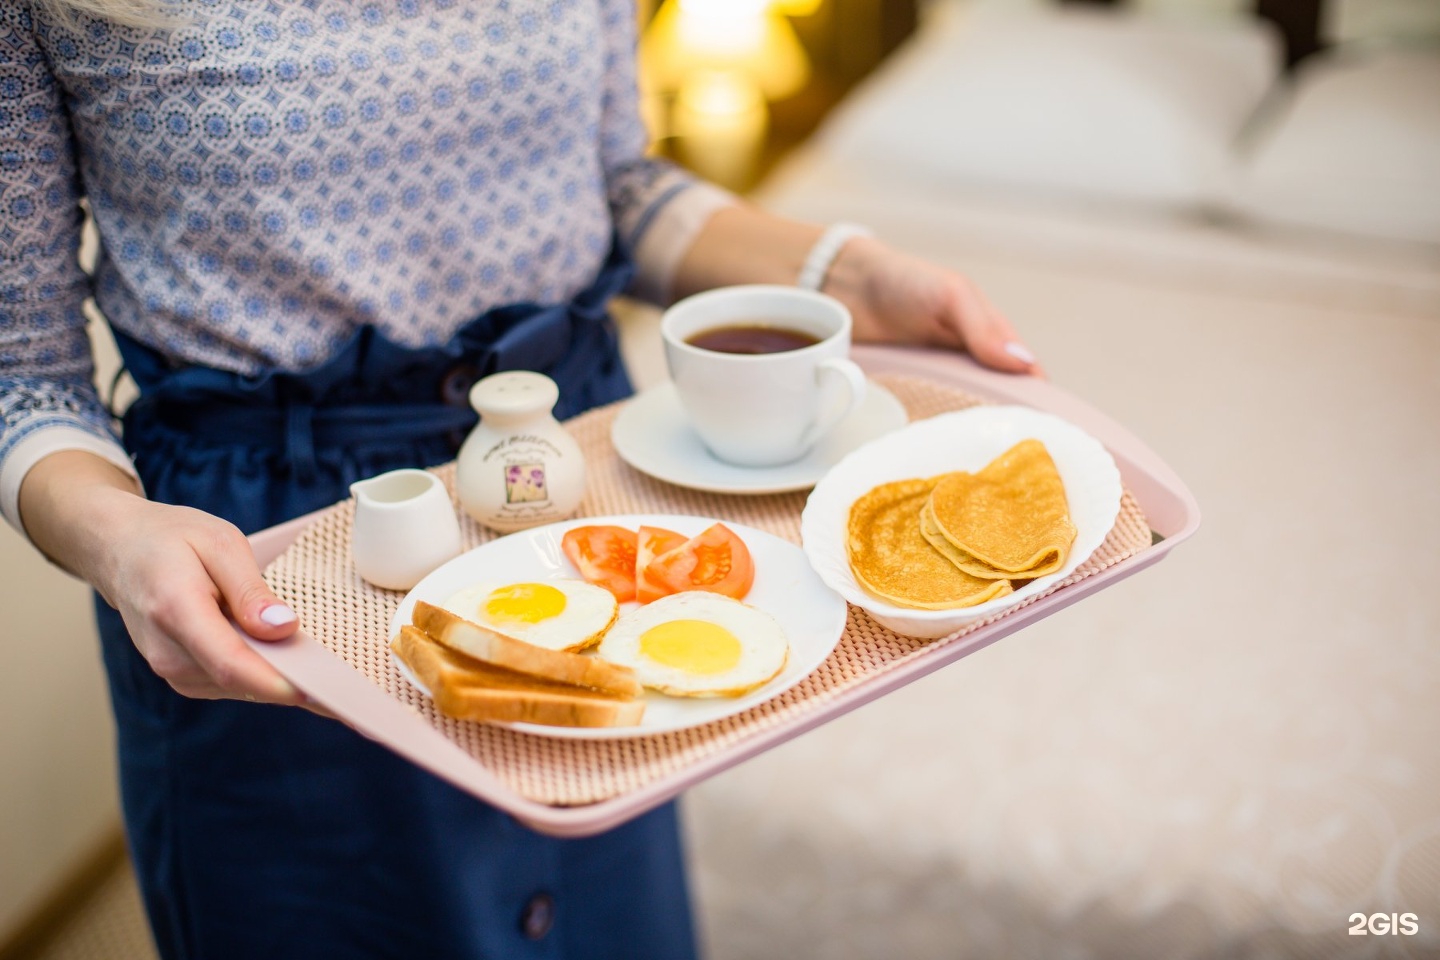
596;590;791;697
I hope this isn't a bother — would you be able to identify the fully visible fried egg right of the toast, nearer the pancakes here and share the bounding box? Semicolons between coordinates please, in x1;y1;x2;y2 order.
598;590;791;697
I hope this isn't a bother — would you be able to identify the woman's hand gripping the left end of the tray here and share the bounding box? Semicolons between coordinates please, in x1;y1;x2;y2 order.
20;450;305;704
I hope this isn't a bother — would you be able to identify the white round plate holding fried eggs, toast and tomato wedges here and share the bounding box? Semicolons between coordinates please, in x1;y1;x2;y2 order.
390;514;845;740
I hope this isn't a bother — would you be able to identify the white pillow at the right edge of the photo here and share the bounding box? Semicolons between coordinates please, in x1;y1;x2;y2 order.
1228;49;1440;243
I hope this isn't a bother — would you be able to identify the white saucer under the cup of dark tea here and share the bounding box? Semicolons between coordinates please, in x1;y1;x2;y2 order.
611;381;910;494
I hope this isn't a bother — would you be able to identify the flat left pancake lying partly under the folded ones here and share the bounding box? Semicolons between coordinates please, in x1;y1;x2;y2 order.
845;478;1011;610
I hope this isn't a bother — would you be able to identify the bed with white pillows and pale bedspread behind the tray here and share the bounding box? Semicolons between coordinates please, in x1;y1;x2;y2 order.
626;0;1440;960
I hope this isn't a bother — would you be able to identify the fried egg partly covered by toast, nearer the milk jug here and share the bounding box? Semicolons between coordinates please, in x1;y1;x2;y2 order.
442;580;619;652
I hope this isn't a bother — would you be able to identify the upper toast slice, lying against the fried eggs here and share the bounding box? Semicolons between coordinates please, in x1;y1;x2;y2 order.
410;600;644;698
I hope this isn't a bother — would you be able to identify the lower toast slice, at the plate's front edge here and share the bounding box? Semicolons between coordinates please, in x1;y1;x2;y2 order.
390;626;645;727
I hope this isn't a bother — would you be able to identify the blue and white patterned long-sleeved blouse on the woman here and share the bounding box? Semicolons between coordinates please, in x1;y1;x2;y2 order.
0;0;719;525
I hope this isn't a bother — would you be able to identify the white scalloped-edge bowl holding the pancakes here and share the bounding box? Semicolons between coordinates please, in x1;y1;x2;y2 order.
801;406;1122;639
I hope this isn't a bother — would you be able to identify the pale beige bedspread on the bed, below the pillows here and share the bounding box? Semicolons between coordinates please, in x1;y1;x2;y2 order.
659;3;1440;960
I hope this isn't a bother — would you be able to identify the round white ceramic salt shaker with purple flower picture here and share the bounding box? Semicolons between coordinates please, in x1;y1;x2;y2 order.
455;370;585;533
